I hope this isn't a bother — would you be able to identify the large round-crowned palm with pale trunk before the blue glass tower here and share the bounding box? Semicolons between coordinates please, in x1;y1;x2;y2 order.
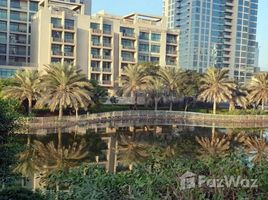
198;67;235;114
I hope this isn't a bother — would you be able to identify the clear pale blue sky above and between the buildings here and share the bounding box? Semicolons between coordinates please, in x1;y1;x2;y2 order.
92;0;268;71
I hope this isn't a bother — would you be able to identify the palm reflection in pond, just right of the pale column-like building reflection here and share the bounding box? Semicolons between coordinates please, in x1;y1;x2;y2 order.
118;135;148;170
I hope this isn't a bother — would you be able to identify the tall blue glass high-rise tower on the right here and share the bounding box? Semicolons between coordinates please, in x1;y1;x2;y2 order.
163;0;259;82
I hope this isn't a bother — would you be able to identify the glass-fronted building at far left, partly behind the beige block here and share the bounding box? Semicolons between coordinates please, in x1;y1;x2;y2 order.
0;0;91;77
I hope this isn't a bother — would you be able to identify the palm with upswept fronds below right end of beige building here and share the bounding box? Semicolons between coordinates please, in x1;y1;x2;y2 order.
159;67;182;110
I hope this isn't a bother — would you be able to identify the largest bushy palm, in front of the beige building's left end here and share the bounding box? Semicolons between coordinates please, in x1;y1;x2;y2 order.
37;64;91;120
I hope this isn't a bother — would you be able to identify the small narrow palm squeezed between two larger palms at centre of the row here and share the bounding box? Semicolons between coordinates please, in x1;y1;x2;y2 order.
148;78;165;110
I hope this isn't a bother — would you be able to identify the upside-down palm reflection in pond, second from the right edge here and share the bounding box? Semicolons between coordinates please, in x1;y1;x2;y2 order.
196;127;230;157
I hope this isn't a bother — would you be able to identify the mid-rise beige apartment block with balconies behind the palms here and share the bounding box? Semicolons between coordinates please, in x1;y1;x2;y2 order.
31;7;179;89
